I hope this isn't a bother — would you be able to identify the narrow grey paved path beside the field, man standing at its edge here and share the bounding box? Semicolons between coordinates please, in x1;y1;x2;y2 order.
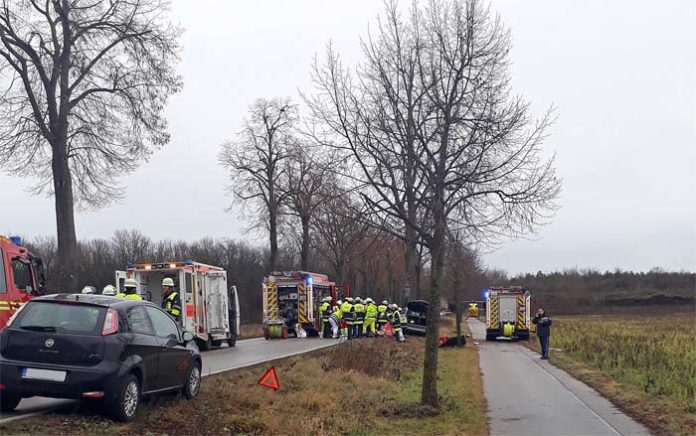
469;319;650;436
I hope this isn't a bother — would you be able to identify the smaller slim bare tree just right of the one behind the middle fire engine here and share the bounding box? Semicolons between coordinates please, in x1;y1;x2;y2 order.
283;142;333;271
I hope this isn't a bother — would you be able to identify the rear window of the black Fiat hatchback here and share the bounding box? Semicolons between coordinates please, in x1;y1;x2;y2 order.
17;301;106;335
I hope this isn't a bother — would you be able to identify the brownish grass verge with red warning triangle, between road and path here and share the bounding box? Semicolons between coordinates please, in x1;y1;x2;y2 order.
0;321;488;435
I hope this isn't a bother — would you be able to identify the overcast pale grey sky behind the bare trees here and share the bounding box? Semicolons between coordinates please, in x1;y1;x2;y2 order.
0;0;696;273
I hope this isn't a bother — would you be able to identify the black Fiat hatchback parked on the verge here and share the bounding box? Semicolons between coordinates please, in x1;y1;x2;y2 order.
0;294;202;421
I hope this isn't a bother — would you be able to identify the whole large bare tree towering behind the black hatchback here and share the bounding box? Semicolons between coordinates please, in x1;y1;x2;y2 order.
0;0;181;288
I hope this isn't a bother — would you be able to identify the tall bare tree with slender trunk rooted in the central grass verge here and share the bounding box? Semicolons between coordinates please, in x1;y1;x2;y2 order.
308;0;560;406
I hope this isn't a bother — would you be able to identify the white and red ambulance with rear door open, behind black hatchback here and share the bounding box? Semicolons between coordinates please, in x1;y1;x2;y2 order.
116;260;240;351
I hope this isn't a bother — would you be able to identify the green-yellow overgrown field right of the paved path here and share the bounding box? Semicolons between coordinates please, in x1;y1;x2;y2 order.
530;313;696;435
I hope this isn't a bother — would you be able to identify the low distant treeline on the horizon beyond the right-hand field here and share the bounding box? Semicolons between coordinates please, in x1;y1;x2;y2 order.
493;268;696;313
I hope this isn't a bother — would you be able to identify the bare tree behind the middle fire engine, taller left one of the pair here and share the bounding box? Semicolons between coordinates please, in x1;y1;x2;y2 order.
219;98;297;271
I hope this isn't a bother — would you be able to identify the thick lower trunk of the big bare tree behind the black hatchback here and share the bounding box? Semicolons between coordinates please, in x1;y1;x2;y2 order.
52;144;79;292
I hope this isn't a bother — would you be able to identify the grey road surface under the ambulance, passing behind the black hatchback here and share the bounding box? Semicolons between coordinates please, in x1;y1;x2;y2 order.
0;338;338;423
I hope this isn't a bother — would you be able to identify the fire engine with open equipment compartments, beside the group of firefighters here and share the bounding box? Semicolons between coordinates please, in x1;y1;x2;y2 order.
262;271;350;339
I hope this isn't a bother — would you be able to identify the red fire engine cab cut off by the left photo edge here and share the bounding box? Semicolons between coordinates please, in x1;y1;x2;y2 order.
0;236;45;329
